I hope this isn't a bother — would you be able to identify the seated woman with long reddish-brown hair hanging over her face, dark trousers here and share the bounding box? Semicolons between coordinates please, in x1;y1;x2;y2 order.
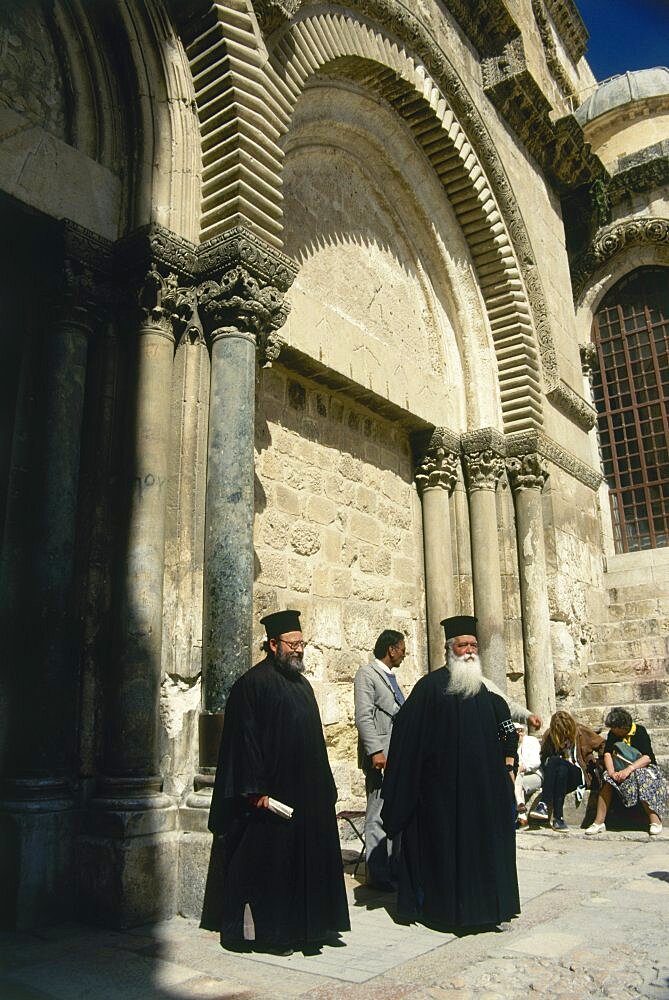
530;712;585;833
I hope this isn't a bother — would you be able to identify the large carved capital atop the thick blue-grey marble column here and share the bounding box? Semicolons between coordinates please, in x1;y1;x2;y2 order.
197;226;297;367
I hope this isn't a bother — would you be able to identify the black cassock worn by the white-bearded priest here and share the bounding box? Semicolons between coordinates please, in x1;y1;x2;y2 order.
381;667;520;929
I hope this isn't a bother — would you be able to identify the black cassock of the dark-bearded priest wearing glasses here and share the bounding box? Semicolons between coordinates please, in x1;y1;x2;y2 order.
202;659;350;946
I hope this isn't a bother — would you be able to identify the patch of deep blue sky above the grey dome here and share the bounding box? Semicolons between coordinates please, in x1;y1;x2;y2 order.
576;0;669;80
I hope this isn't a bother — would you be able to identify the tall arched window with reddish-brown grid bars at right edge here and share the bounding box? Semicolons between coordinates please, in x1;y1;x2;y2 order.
592;267;669;552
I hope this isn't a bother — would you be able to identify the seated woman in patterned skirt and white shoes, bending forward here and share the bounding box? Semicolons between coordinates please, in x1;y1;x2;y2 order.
585;708;667;837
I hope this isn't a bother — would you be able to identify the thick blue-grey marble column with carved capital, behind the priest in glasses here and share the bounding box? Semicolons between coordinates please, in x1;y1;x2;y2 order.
179;228;297;917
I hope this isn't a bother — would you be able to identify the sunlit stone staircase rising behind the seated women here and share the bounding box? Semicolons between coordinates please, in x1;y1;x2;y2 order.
578;573;669;778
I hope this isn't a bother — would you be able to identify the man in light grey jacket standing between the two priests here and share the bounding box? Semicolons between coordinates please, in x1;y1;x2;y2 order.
353;629;406;892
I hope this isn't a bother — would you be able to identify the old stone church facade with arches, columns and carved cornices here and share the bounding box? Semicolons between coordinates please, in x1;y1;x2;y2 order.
0;0;669;928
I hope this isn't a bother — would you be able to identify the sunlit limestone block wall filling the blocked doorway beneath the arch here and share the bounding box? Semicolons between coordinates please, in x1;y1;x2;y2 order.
254;365;427;803
